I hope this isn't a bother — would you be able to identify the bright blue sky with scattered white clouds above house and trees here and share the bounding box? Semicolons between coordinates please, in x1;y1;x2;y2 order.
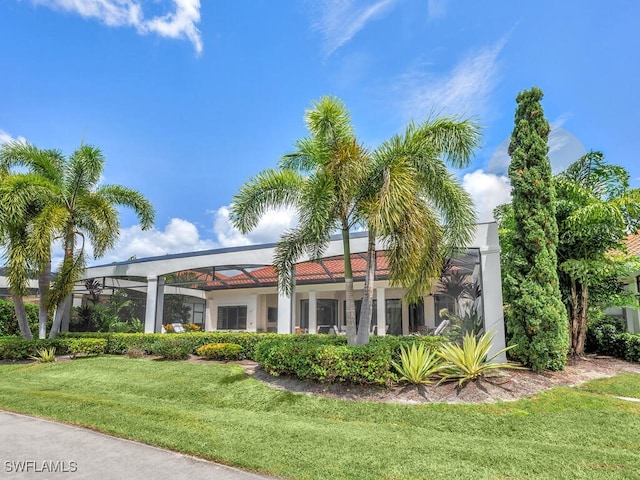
0;0;640;263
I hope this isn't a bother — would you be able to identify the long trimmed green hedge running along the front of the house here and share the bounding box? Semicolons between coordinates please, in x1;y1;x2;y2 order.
0;332;445;384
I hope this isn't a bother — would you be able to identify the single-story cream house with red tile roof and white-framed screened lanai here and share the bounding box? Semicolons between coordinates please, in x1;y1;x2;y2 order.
71;222;505;358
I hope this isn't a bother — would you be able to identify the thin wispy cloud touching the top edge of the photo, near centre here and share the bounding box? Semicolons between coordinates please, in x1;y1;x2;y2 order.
312;0;398;57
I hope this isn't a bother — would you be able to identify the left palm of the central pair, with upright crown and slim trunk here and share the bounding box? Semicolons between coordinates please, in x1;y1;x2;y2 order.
230;96;368;344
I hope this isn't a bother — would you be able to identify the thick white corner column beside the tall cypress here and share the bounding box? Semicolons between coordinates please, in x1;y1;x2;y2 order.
480;246;507;362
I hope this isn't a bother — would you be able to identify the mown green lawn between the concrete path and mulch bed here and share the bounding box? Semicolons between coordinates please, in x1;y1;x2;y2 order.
0;357;640;480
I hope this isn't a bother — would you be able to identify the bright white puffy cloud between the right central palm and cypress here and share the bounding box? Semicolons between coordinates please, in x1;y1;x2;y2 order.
462;169;511;222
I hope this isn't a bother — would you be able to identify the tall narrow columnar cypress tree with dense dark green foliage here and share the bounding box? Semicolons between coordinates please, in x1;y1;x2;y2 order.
505;87;568;370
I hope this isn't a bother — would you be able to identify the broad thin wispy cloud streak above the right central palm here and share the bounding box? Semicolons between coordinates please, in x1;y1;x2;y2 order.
394;35;508;120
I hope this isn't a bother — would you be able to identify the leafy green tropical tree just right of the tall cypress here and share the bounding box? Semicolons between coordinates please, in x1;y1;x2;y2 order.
555;151;640;355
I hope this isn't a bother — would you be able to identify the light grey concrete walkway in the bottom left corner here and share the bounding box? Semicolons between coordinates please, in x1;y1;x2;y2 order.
0;411;280;480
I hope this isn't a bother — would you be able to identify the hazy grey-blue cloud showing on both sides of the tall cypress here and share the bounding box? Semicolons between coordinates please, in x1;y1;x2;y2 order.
488;125;587;173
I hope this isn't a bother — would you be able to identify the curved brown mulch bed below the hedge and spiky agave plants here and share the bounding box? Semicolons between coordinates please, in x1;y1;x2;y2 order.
234;355;640;404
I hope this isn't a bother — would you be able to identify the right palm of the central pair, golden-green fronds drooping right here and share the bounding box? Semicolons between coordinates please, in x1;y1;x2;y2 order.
357;117;480;344
